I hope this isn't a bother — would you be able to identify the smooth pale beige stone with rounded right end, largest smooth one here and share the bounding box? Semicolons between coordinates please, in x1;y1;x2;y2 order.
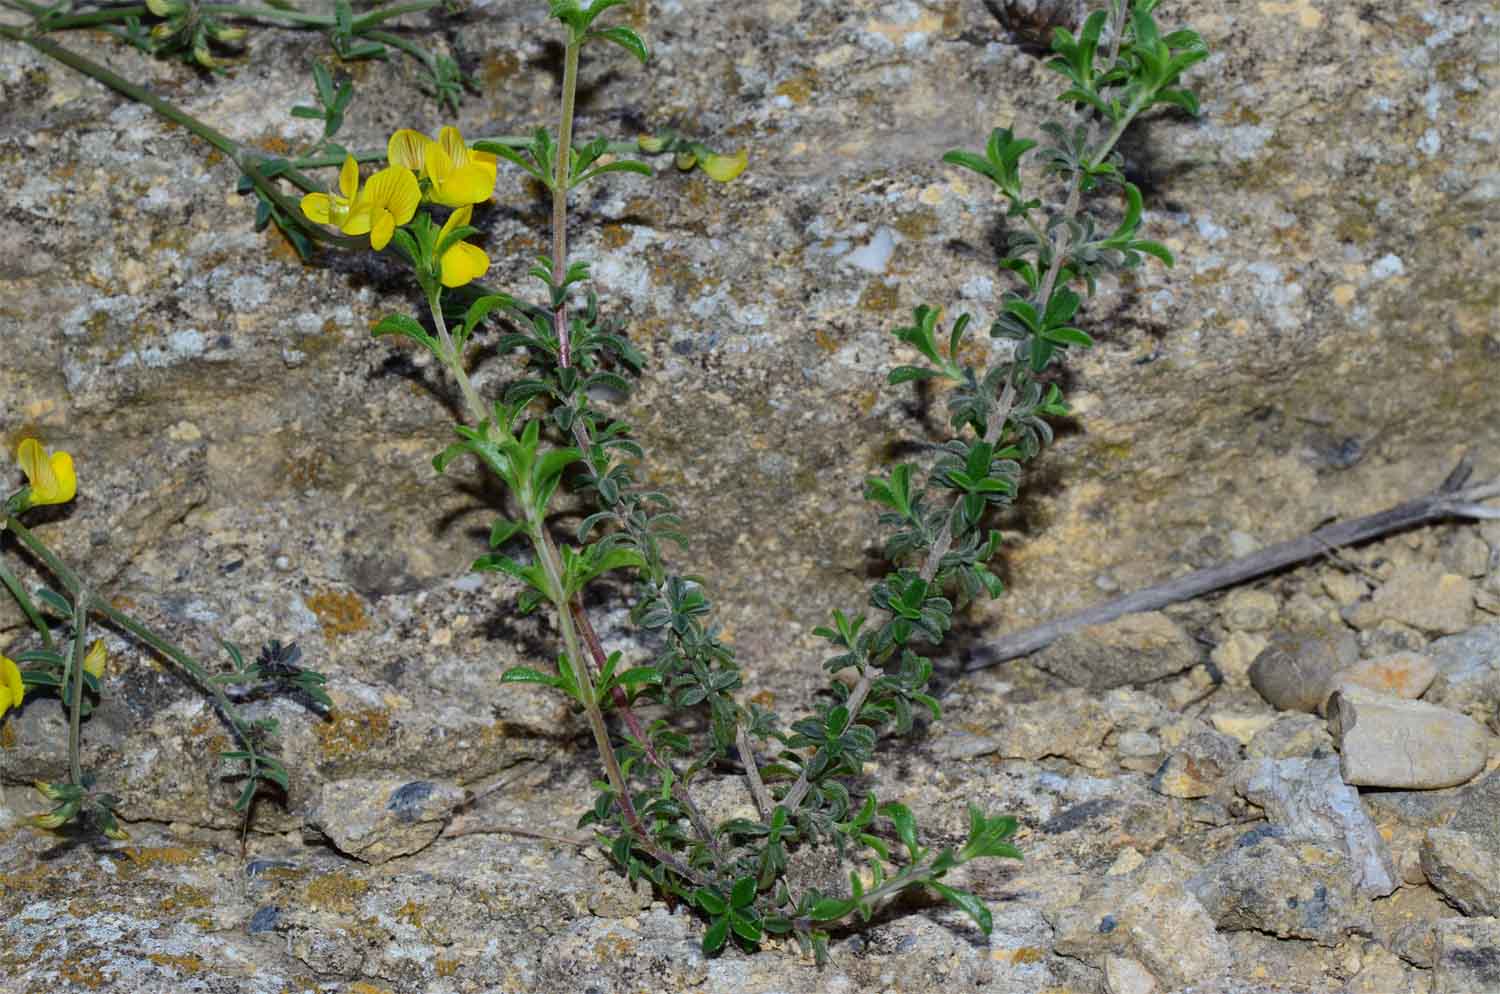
1329;687;1490;790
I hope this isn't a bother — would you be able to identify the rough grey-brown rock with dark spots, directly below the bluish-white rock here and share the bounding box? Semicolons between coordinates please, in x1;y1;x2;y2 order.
1188;832;1371;946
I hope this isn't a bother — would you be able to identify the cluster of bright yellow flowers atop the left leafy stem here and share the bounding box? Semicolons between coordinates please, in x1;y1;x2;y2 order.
302;127;497;286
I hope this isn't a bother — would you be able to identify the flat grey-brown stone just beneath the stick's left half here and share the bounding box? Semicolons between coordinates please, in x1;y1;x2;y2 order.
1035;612;1199;690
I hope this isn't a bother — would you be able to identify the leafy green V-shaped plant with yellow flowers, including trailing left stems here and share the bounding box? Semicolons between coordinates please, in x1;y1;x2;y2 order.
0;0;1206;963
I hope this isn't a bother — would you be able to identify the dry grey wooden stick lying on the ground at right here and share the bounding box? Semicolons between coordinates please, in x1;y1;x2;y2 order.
963;454;1500;672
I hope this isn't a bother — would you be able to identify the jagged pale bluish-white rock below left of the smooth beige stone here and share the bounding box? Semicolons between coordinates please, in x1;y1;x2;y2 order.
1235;757;1400;897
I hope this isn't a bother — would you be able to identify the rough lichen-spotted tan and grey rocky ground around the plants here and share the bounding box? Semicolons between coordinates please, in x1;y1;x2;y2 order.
0;0;1500;994
